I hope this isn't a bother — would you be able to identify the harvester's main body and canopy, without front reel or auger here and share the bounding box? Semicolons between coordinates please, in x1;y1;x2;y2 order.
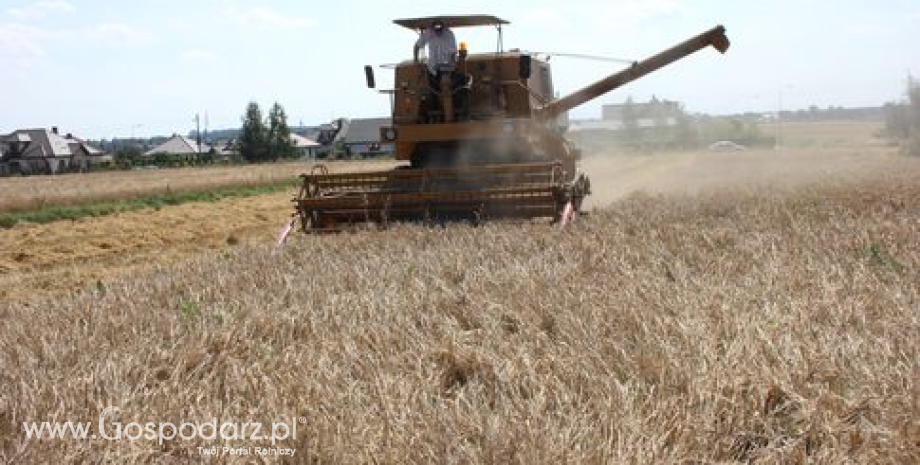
368;15;575;172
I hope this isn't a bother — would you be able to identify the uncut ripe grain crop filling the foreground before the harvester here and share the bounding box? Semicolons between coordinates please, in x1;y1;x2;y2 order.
0;169;920;463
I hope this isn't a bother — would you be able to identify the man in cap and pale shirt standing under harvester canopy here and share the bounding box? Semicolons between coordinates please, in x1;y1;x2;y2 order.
412;20;470;121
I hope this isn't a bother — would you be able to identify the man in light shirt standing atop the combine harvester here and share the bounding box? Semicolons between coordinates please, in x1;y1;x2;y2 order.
412;19;471;123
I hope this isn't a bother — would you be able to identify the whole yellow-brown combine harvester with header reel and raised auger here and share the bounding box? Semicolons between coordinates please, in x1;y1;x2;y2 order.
294;15;729;232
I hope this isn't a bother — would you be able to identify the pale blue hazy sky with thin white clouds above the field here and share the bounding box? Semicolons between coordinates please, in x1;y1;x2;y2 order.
0;0;920;139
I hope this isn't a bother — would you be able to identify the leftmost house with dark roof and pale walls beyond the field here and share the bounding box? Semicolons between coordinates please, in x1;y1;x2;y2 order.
0;127;114;175
